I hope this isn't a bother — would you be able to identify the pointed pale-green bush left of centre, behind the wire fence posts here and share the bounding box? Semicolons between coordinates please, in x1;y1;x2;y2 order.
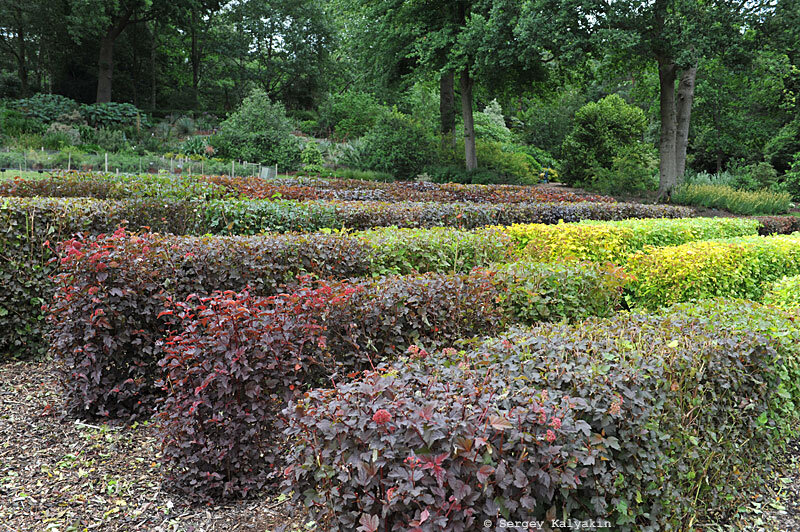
214;90;303;170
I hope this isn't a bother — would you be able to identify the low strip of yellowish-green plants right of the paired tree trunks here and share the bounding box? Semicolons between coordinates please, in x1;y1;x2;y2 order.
672;185;792;215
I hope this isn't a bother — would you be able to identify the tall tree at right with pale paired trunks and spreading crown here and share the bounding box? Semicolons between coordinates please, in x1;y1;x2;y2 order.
520;0;772;196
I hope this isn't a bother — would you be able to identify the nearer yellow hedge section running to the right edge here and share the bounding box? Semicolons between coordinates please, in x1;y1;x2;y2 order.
626;233;800;308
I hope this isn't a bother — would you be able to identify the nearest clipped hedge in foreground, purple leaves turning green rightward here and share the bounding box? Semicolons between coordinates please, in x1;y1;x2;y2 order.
283;301;800;532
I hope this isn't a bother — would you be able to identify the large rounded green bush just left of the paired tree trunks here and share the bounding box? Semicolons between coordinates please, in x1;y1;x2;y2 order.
561;94;646;185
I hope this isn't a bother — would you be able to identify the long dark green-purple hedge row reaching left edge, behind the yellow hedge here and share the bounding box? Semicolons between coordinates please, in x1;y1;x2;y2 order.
0;195;680;356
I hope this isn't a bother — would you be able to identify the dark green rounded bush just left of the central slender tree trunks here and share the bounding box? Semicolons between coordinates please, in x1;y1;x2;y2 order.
364;111;436;179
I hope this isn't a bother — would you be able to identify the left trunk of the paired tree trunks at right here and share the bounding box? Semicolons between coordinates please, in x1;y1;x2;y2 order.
658;59;678;199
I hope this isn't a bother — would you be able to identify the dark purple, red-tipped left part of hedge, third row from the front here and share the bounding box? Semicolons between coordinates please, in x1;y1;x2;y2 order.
44;230;369;417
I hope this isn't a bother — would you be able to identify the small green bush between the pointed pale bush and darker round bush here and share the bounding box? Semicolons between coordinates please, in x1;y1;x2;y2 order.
317;90;389;139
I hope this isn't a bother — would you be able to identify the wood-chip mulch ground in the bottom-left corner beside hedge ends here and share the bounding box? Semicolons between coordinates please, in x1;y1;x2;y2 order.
0;362;298;532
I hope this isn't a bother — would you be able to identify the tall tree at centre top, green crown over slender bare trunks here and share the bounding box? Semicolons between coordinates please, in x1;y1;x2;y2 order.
357;0;541;170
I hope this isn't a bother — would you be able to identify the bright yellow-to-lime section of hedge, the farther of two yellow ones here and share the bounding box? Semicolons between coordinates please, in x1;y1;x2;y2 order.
506;218;760;264
